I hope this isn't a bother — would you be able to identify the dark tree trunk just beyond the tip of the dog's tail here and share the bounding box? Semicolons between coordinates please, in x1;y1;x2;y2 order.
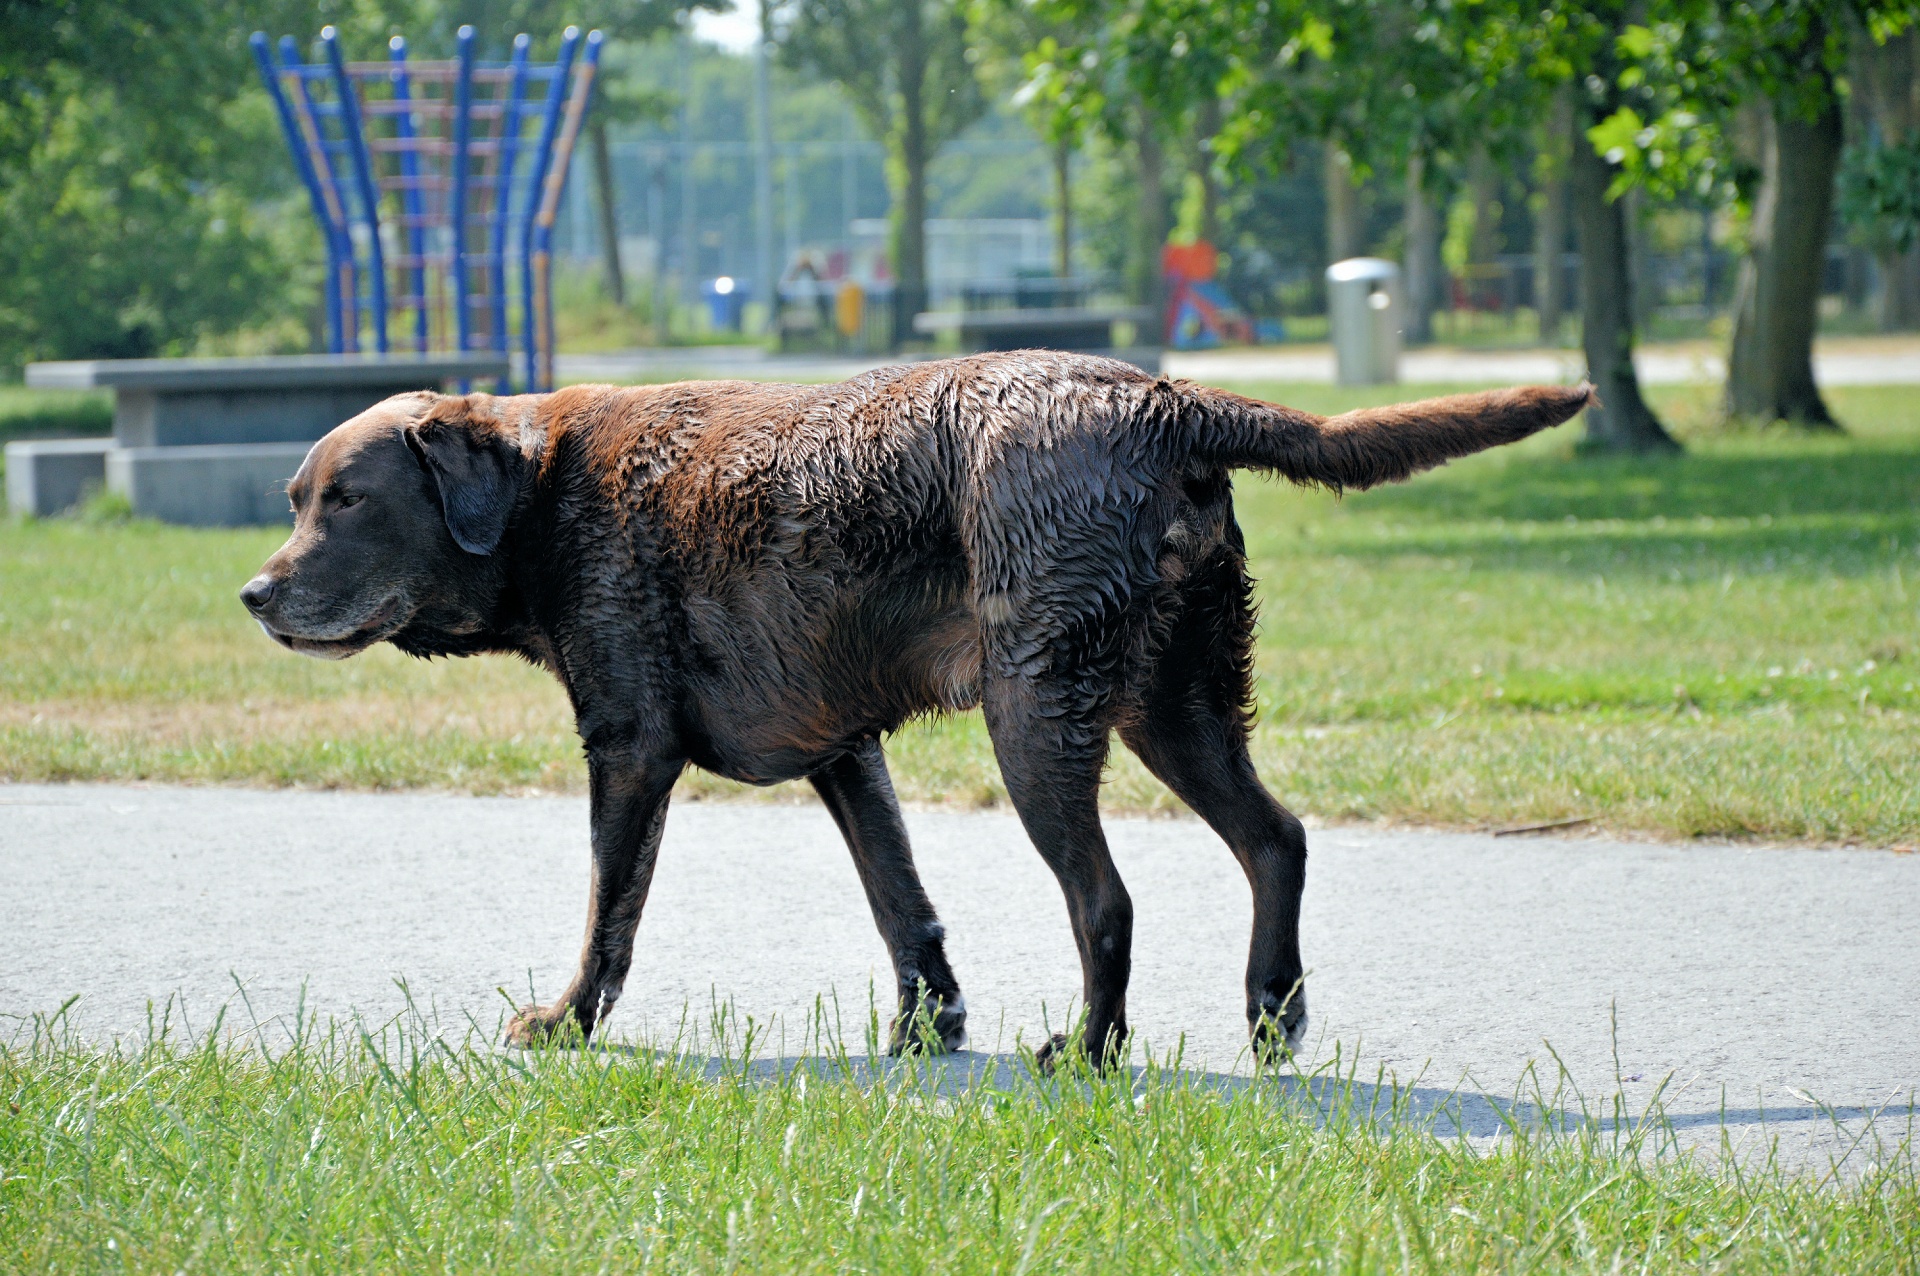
1567;104;1680;453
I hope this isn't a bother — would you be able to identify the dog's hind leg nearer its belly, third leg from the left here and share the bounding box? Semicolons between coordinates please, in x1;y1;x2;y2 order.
981;675;1133;1067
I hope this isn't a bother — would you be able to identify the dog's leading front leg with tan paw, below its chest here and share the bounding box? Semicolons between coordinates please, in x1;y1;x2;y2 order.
507;748;682;1046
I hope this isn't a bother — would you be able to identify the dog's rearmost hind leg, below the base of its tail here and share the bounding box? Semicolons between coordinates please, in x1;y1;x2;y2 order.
1119;528;1308;1059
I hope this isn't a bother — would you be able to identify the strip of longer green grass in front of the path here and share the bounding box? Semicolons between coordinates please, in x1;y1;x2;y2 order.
0;1023;1920;1274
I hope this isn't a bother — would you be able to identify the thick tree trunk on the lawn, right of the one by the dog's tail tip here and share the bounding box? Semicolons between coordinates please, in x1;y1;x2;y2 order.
1726;84;1841;430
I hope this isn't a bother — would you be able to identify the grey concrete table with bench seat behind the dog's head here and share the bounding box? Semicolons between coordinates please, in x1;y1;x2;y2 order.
6;351;507;526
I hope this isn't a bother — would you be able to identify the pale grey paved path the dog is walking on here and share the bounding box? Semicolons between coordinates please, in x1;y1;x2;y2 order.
0;785;1920;1157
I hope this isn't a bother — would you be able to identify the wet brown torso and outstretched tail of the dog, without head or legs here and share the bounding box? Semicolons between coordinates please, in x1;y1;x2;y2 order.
526;351;1588;781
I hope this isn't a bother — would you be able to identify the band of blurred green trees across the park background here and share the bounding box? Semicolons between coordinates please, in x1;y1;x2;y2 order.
0;0;1920;437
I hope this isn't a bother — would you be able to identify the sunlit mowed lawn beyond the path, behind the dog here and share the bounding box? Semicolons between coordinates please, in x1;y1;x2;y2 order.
0;386;1920;844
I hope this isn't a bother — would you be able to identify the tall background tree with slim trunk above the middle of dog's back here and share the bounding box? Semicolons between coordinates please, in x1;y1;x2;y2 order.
780;0;987;340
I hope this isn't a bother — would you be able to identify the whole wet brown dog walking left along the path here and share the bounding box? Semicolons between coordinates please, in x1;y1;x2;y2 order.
242;351;1590;1059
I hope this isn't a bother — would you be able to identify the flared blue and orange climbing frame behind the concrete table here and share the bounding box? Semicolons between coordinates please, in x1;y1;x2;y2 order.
252;27;603;393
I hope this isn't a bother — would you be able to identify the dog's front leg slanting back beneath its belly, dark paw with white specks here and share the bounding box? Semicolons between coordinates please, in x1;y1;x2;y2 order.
810;739;966;1053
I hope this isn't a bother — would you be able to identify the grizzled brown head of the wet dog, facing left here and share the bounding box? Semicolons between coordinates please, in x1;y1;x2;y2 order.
240;393;532;660
